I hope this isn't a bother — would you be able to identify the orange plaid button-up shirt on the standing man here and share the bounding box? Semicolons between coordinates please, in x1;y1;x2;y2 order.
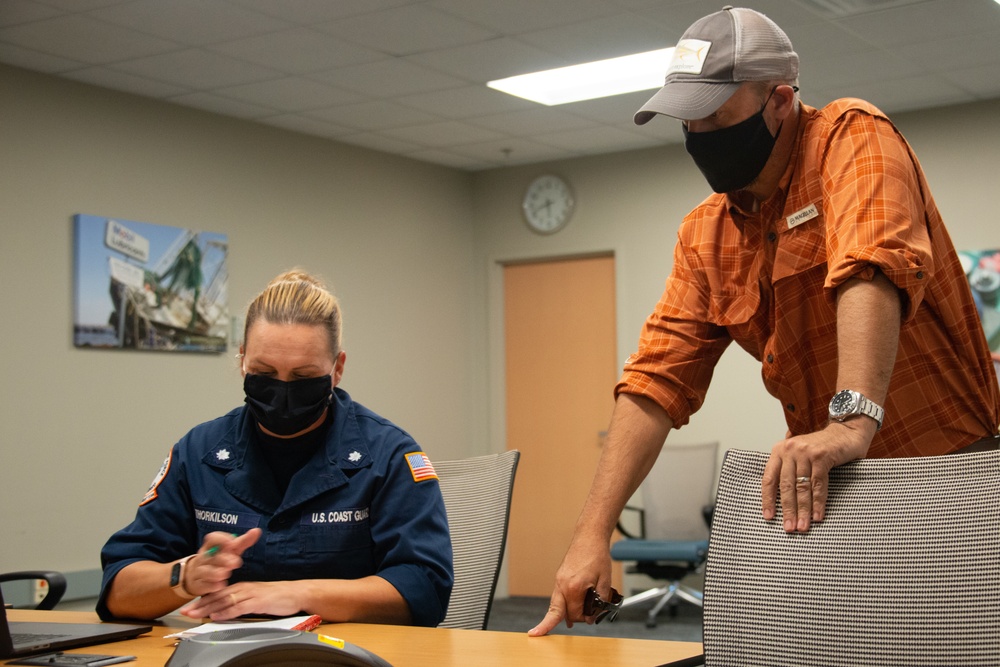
615;100;1000;456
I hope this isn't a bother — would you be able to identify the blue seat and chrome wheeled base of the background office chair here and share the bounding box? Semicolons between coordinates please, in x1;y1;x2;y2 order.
611;539;708;628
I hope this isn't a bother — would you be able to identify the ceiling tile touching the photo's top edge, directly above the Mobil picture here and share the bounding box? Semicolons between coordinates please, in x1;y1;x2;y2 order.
90;0;289;46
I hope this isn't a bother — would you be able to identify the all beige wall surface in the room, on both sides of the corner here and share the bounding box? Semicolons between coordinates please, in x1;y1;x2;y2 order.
0;61;1000;584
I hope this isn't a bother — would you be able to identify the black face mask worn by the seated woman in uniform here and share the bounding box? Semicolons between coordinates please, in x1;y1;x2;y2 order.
243;373;333;435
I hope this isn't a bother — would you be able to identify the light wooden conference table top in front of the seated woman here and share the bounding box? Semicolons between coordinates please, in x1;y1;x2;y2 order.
4;609;702;667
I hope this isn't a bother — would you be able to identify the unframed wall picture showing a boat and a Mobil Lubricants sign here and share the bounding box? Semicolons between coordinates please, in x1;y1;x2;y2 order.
73;214;229;352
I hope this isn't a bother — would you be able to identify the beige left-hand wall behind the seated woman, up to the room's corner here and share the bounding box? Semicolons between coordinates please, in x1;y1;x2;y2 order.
0;67;478;571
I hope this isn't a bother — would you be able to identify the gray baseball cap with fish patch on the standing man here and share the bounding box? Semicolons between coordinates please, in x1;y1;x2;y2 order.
633;6;799;125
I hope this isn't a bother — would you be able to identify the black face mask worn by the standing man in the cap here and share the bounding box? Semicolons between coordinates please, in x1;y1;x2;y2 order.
684;89;781;193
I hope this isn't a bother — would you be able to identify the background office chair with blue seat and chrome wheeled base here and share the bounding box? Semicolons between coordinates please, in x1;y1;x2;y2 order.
611;442;719;628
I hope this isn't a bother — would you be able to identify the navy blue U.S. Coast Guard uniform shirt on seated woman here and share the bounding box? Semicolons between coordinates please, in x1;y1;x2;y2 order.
97;389;454;626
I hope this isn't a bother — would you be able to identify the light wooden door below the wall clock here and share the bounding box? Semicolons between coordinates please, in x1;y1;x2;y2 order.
504;256;620;597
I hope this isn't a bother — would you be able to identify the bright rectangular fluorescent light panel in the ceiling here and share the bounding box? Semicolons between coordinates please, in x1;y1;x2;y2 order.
486;47;676;106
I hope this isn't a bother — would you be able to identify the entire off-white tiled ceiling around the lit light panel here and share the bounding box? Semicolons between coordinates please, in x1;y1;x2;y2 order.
0;0;1000;170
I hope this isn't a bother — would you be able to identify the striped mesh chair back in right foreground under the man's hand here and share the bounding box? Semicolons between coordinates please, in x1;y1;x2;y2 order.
703;451;1000;667
